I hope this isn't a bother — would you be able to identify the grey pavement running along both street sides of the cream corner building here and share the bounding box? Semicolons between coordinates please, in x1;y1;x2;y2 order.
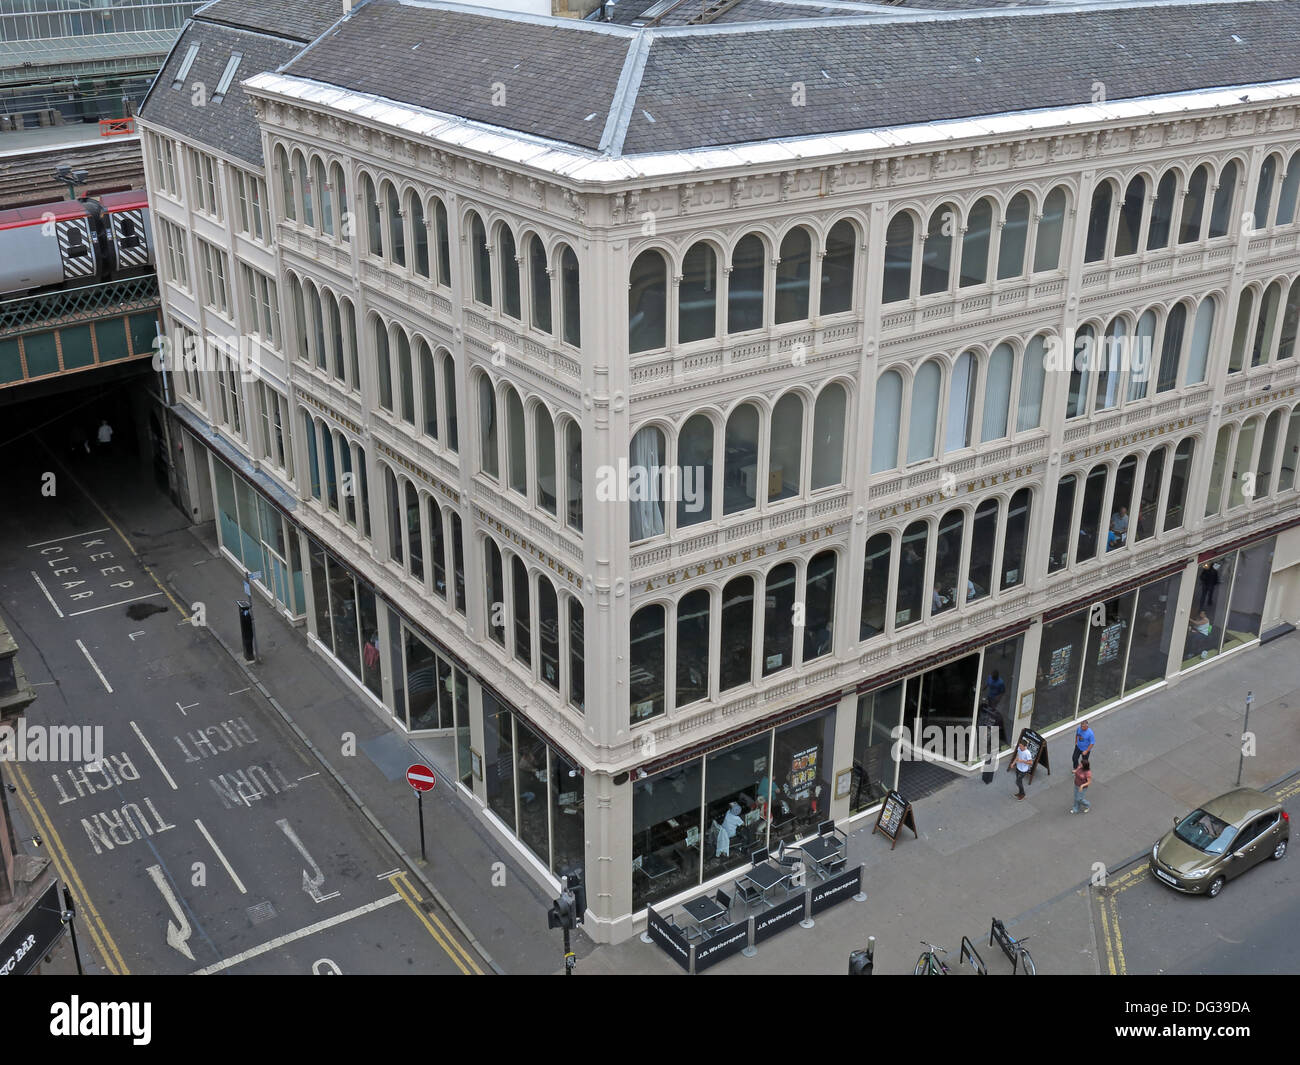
22;439;1300;975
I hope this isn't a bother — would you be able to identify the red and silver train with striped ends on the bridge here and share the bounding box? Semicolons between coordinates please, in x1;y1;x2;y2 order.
0;189;156;300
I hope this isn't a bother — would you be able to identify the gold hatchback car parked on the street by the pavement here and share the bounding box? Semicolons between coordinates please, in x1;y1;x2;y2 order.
1149;788;1291;899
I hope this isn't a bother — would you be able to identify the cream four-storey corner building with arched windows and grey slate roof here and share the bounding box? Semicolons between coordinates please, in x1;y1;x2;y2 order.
143;0;1300;940
